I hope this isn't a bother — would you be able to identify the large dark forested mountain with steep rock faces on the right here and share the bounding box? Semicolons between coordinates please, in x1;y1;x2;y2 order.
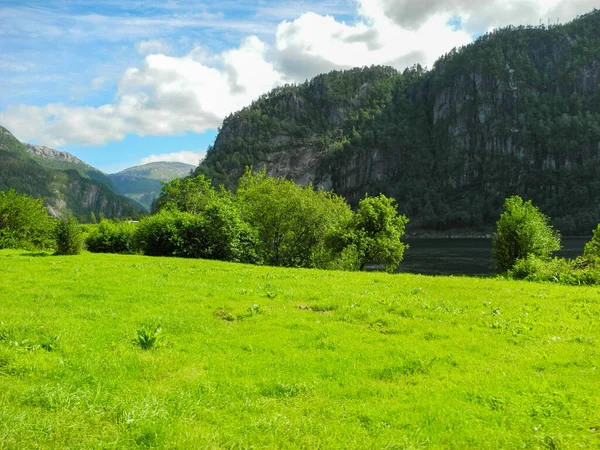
194;10;600;234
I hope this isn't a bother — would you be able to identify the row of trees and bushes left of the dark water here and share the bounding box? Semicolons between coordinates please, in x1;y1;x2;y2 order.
0;169;408;271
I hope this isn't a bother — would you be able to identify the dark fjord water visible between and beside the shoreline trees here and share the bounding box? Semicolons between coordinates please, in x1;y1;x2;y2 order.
399;237;589;275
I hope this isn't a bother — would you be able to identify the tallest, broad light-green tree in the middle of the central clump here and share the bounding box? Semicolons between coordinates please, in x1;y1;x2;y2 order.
236;170;352;267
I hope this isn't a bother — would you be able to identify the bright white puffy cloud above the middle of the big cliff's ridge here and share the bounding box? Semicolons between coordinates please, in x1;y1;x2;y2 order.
275;11;472;80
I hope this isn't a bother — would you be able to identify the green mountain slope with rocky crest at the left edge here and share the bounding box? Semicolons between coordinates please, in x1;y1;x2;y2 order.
0;126;139;218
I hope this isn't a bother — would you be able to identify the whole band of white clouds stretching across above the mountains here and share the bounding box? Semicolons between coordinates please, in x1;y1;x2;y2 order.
0;0;597;148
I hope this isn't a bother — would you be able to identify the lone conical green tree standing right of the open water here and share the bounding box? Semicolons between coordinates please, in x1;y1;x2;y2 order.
492;195;560;272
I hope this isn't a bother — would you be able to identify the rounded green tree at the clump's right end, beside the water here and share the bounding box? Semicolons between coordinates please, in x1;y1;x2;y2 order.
345;194;408;272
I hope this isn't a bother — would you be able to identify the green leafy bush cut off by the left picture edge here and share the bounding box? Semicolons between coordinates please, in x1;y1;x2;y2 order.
0;189;54;249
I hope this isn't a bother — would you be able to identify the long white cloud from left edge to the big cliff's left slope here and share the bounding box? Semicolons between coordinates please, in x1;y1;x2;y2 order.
0;37;284;147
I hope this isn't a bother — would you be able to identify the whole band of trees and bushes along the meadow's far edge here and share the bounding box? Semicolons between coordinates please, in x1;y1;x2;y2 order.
0;174;600;284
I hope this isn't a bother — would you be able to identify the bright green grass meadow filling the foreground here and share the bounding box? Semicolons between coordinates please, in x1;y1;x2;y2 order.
0;251;600;449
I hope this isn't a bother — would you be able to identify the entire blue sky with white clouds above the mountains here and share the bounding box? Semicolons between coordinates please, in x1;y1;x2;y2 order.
0;0;597;172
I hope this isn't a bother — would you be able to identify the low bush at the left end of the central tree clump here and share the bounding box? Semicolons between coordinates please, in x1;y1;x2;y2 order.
85;219;136;253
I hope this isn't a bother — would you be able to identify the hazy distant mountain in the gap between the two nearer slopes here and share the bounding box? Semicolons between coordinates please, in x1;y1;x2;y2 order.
108;162;195;210
